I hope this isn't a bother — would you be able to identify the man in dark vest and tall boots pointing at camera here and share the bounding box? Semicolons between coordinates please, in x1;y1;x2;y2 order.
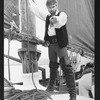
29;0;76;100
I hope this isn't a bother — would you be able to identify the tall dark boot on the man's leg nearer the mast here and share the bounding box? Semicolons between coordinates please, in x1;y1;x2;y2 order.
46;62;59;92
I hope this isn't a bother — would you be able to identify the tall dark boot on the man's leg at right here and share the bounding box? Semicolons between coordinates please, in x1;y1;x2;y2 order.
60;57;76;100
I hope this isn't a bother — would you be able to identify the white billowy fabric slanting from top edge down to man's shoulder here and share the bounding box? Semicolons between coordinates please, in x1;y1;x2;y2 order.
28;0;48;21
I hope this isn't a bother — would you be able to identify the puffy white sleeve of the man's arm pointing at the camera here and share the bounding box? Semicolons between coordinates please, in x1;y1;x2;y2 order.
54;12;67;28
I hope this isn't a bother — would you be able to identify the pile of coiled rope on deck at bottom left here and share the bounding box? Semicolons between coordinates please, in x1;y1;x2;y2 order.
7;89;53;100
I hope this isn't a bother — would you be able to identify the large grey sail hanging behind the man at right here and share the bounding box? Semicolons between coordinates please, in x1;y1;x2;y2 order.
58;0;94;53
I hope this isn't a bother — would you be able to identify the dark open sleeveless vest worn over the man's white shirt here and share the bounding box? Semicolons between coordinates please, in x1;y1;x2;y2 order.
44;12;69;48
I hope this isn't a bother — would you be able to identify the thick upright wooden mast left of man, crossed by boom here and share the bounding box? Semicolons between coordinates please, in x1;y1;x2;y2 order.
18;0;41;73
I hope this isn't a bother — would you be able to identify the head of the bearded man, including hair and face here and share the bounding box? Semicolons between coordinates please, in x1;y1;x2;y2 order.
46;0;58;15
